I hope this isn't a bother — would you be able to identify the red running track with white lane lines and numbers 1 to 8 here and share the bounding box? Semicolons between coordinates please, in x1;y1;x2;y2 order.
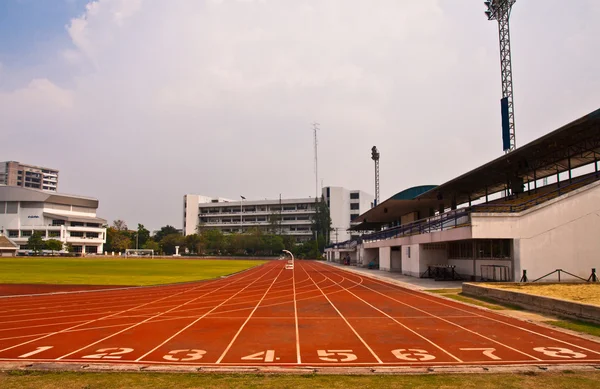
0;261;600;367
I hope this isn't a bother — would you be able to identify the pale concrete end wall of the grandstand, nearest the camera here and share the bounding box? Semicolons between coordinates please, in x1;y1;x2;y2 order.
472;182;600;280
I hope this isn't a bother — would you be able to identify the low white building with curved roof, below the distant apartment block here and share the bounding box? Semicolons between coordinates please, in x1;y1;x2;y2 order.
0;185;106;254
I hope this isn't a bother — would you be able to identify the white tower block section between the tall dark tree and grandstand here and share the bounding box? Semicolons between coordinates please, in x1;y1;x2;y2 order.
323;186;375;243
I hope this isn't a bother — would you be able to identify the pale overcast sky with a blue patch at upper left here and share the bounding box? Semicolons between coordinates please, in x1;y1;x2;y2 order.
0;0;600;229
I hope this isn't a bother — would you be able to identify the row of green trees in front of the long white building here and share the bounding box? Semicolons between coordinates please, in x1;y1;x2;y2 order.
104;199;331;258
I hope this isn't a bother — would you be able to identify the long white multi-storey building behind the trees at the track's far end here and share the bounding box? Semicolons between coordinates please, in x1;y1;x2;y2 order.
183;194;315;242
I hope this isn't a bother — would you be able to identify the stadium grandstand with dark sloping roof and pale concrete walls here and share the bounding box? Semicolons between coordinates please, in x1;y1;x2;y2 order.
326;109;600;281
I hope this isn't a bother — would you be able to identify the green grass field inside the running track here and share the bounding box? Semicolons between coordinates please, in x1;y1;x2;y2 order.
0;257;266;286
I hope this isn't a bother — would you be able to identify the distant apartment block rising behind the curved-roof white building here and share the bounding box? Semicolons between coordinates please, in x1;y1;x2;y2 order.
0;161;58;192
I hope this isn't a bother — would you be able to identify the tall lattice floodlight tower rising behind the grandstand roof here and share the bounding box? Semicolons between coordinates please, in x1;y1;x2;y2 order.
484;0;517;153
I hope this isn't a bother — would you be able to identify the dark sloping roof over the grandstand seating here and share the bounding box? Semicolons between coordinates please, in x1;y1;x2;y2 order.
353;109;600;230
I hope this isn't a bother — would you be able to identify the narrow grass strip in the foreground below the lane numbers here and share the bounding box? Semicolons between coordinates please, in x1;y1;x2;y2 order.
0;370;600;389
